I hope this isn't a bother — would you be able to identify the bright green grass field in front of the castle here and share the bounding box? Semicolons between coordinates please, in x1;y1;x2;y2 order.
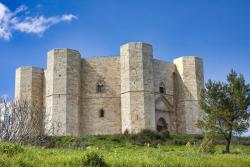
0;136;250;167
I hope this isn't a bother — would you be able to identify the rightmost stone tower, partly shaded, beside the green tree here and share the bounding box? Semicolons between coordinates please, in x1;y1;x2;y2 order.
174;56;204;134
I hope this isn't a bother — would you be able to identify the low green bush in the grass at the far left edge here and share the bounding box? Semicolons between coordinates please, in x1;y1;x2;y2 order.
0;142;24;156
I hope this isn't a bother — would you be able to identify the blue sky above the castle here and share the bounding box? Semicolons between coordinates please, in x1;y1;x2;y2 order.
0;0;250;132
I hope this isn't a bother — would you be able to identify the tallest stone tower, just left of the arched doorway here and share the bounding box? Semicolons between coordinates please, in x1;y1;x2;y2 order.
120;42;155;133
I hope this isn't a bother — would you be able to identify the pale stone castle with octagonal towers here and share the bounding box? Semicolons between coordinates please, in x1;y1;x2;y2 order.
15;42;204;136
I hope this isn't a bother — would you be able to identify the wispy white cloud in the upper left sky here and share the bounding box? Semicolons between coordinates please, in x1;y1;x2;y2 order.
0;2;77;40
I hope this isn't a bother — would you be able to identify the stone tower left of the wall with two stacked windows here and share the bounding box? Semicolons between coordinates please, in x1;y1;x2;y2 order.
46;49;81;136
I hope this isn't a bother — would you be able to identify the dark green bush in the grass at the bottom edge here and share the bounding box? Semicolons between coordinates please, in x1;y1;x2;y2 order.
82;152;108;167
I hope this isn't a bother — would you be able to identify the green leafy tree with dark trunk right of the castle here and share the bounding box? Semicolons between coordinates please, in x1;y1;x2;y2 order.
198;70;250;153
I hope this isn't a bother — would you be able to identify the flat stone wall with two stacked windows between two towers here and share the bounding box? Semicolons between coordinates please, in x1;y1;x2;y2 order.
80;57;121;134
